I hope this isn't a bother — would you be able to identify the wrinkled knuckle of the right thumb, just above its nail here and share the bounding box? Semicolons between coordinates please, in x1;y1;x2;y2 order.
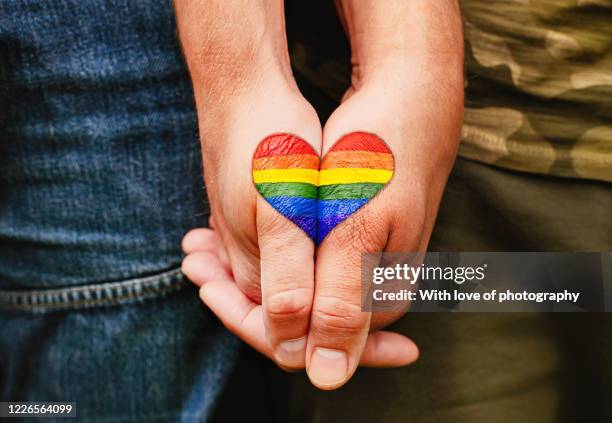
311;297;367;336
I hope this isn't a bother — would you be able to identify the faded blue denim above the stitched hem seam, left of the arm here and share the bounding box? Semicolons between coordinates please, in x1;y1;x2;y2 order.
0;0;208;288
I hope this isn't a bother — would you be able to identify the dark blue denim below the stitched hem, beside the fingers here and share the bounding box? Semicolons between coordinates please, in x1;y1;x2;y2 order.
0;271;238;422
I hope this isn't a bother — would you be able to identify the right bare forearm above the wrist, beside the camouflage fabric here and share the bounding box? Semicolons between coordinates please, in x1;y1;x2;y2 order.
336;0;463;92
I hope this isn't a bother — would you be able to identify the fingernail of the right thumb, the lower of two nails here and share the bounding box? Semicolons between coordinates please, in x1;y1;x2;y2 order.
308;348;348;387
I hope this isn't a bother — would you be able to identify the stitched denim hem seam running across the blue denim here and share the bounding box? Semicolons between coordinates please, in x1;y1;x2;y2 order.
0;269;188;312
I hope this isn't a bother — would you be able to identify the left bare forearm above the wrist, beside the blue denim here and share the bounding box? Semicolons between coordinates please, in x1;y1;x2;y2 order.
174;0;291;99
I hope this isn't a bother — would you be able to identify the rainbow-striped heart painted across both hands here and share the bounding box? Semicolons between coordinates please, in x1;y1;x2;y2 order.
253;132;394;245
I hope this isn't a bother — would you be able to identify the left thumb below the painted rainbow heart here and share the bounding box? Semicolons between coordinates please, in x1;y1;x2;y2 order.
257;198;316;368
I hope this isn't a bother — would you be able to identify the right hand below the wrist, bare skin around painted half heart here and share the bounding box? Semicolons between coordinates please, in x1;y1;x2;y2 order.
306;54;461;389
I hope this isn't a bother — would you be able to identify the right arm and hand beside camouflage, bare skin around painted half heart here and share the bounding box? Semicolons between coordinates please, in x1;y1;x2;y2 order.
292;0;463;389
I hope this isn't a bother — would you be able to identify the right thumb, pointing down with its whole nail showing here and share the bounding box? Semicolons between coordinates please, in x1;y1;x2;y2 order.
306;206;388;389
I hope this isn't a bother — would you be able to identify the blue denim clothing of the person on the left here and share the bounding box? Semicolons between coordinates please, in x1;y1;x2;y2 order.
0;0;238;421
